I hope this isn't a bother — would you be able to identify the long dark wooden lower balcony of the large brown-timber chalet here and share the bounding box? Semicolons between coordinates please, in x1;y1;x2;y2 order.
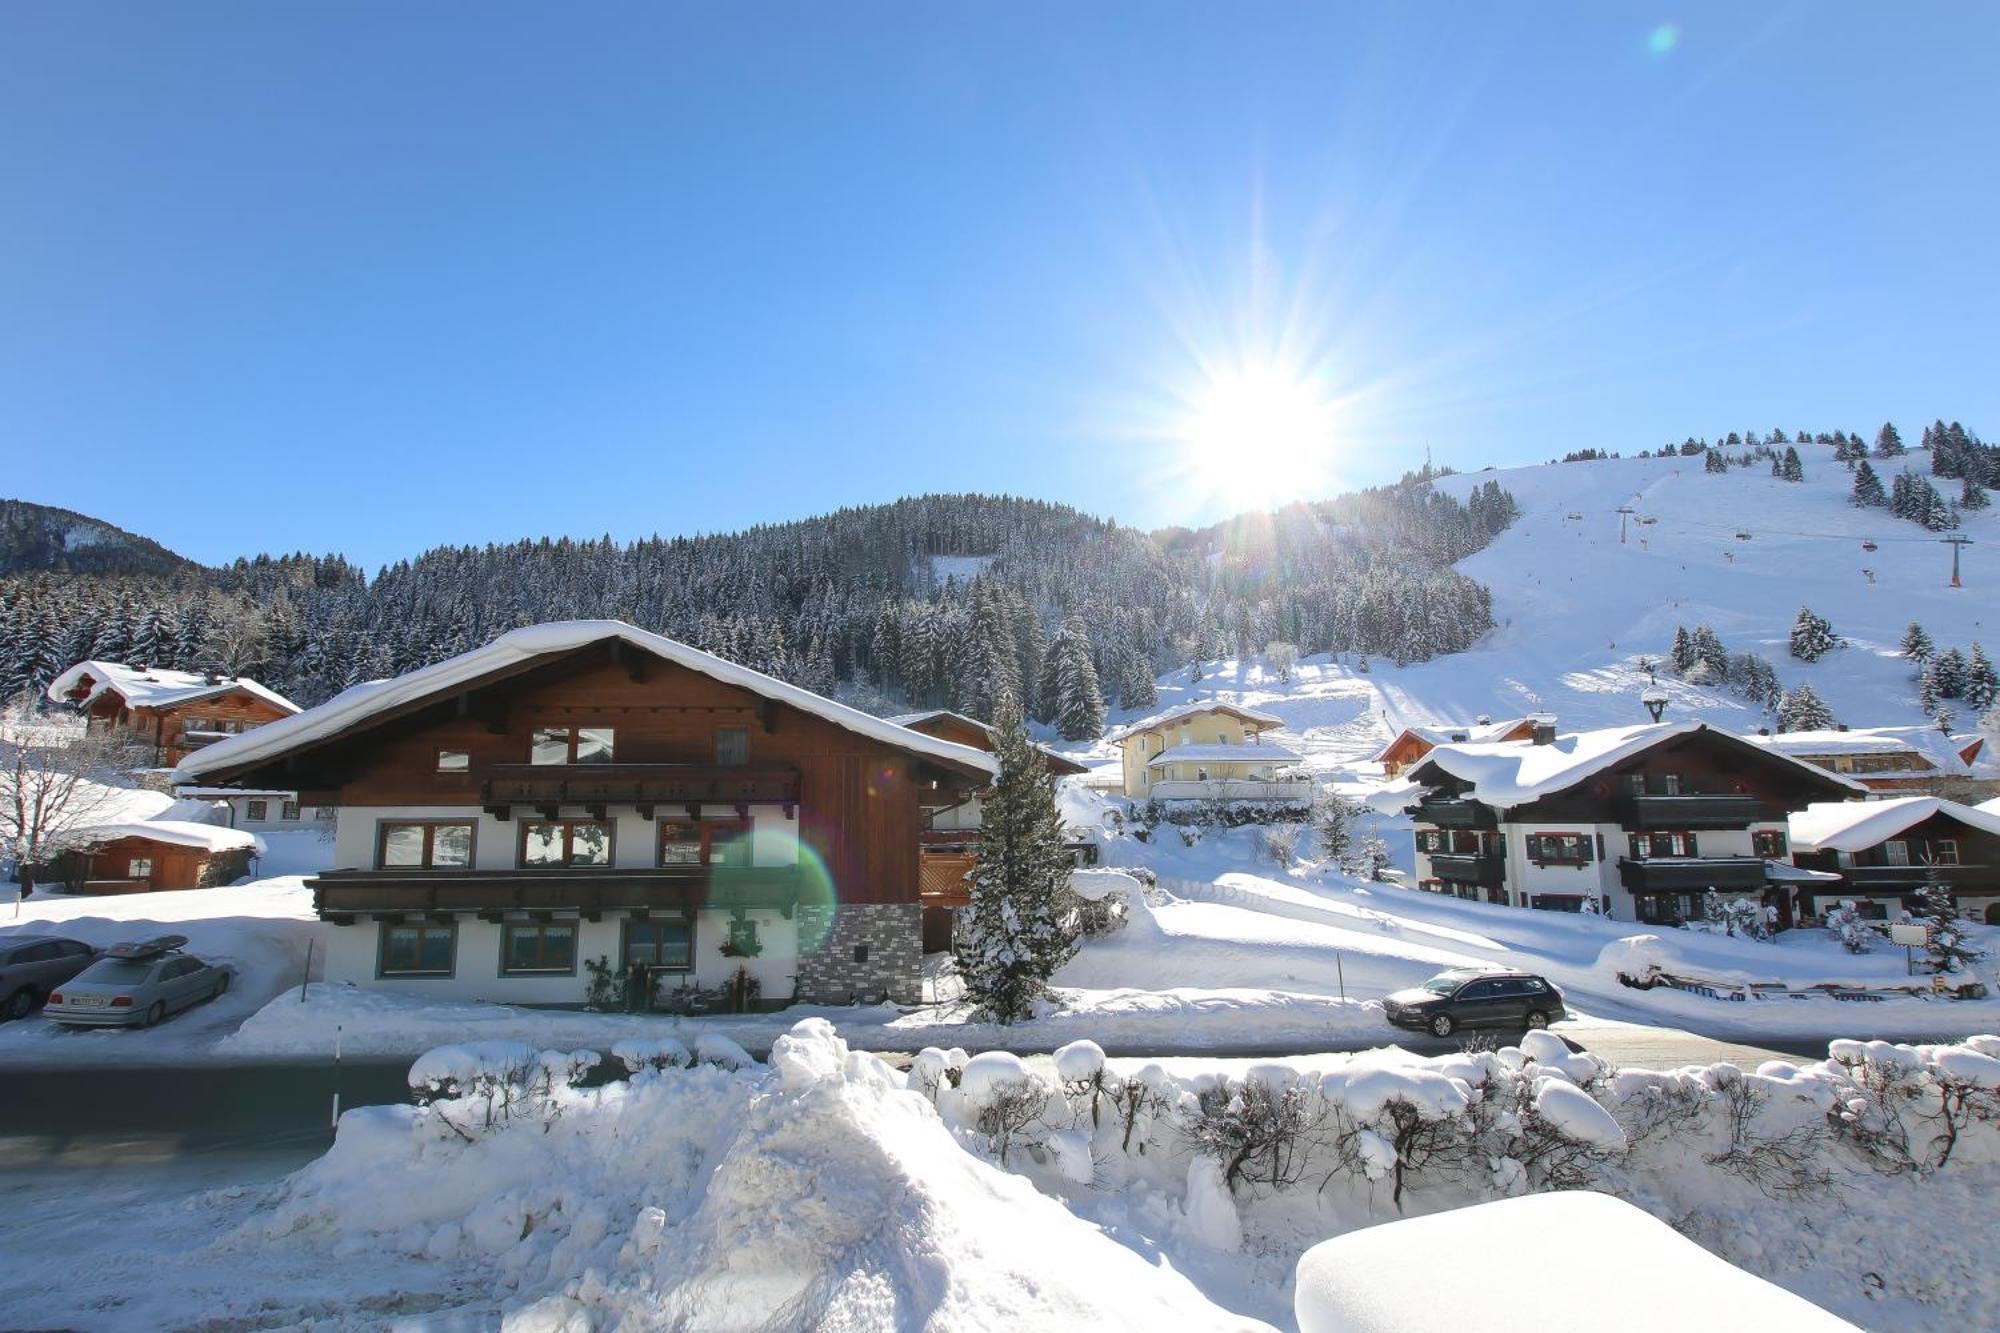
306;865;798;921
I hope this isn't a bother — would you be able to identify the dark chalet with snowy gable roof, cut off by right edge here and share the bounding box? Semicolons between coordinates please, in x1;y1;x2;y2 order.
1792;797;2000;925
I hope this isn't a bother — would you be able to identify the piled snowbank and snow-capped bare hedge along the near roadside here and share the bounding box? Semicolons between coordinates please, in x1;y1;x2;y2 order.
244;1019;2000;1329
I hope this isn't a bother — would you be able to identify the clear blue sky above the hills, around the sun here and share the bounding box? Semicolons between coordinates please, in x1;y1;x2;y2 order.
0;4;2000;566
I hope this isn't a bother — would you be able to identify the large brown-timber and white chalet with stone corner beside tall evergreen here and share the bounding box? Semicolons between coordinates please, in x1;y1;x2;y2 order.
176;620;996;1005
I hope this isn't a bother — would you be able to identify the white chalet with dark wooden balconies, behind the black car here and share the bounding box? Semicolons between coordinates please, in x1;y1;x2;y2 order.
1370;723;1866;925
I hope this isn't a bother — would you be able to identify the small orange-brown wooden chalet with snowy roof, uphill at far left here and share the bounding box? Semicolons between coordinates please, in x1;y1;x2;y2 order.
48;660;298;769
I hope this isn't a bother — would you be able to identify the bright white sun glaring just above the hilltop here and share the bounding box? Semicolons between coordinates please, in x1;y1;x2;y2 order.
1182;366;1338;506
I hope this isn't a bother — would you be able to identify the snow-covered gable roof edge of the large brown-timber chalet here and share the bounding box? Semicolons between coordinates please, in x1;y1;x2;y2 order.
174;620;1000;781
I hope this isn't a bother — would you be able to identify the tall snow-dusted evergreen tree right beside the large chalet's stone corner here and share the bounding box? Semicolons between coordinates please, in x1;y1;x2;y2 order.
956;695;1076;1023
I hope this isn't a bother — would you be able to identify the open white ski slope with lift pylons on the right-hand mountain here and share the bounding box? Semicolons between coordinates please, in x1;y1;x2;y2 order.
1112;444;2000;763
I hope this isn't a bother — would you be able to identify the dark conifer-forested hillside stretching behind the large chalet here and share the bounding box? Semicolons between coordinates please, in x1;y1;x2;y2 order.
0;472;1516;717
